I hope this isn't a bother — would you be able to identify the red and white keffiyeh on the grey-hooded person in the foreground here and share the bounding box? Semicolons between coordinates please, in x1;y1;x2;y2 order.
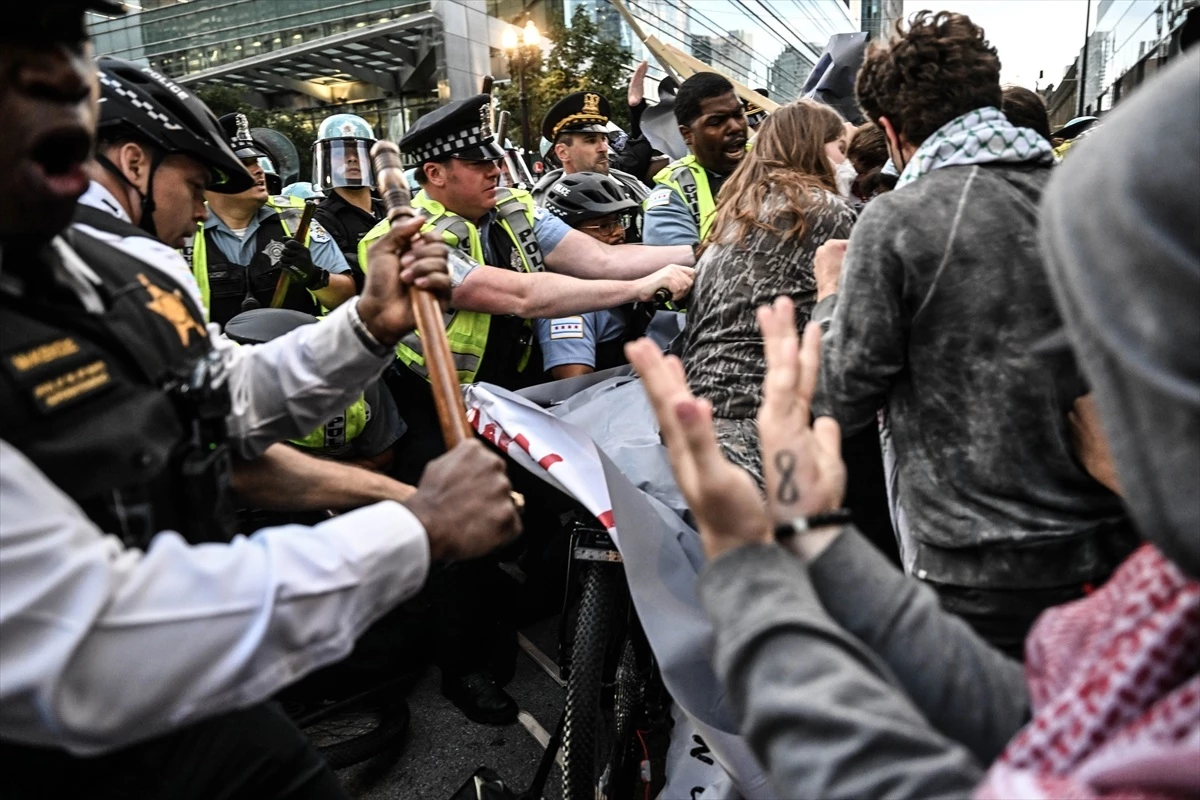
976;545;1200;800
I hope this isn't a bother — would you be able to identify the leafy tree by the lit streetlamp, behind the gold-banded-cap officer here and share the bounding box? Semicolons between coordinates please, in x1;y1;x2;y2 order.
496;6;634;148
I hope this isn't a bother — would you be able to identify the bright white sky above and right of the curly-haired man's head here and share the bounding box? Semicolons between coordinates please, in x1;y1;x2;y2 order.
905;0;1097;89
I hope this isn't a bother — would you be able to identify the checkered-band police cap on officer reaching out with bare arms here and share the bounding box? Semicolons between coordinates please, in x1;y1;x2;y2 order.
400;95;504;167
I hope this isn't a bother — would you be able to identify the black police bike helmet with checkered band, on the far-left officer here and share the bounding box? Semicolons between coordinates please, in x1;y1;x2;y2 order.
97;56;254;194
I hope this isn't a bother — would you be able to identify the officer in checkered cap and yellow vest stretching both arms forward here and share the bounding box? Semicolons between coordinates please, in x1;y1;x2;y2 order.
360;95;694;400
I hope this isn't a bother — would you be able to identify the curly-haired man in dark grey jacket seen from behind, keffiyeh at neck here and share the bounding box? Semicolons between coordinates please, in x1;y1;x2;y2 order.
814;12;1135;656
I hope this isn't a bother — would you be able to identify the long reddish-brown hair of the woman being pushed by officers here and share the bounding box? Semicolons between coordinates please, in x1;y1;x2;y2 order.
708;100;845;250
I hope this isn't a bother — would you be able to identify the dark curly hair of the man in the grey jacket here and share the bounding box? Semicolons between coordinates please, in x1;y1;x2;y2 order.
857;11;1001;145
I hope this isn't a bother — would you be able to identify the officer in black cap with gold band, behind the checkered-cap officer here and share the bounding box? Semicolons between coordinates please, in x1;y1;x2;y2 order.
533;91;647;242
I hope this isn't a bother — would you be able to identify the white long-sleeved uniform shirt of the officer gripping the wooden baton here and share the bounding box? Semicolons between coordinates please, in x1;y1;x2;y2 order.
0;231;430;754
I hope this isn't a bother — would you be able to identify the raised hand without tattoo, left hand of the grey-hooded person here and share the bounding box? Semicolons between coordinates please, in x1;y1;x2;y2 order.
625;339;770;558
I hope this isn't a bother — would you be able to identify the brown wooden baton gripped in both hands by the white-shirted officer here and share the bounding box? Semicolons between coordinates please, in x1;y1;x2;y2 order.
371;140;473;450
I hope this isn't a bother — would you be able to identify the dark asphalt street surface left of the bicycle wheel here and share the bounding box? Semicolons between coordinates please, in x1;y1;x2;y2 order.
338;618;566;800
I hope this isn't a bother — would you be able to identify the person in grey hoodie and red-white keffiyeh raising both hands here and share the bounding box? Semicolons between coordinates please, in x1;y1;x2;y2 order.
630;45;1200;800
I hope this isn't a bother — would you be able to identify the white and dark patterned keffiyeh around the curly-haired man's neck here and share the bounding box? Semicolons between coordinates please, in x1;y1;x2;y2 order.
896;106;1054;188
